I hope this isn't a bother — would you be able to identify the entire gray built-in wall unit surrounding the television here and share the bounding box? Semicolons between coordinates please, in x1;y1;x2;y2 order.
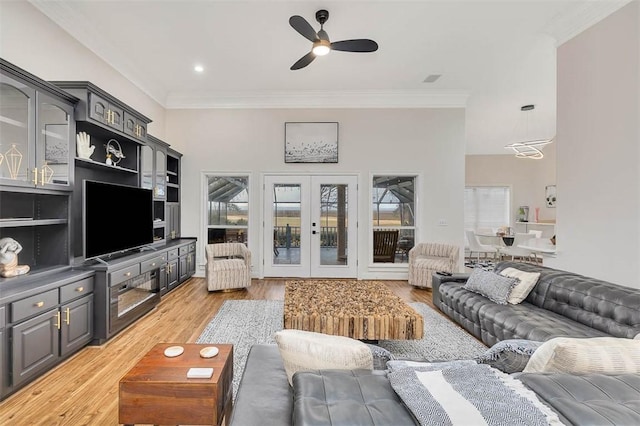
0;58;195;399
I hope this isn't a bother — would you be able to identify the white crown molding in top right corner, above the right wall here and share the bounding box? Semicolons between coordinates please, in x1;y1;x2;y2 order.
542;0;633;46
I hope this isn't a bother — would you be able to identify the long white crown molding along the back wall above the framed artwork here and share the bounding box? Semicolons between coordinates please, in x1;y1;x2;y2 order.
166;90;469;109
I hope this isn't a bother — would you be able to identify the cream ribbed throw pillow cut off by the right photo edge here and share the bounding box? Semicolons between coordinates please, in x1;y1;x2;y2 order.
524;337;640;374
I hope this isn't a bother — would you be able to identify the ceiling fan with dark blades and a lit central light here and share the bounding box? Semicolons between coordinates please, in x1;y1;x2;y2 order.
289;10;378;70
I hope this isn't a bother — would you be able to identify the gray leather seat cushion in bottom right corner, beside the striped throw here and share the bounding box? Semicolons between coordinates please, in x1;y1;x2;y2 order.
518;373;640;426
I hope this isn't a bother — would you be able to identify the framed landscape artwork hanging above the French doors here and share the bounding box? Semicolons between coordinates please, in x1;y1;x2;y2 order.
284;122;338;163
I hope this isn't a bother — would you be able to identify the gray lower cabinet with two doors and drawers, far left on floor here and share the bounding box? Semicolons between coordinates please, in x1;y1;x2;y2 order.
0;271;94;397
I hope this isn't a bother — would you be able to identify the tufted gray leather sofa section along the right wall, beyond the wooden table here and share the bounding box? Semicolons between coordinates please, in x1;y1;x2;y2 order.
433;262;640;346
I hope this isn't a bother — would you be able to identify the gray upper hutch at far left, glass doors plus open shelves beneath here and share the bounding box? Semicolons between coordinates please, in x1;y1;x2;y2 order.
0;59;78;287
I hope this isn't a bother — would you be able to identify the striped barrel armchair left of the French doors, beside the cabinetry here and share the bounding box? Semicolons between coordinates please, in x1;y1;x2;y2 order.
205;243;251;291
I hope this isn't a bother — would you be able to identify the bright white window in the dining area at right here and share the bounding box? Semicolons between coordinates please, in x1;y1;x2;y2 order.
464;186;511;232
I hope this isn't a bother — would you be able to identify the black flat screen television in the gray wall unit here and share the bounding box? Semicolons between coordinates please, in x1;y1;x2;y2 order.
82;180;153;260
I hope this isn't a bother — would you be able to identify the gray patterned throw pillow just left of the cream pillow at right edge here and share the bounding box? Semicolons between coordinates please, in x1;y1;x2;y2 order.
474;339;544;374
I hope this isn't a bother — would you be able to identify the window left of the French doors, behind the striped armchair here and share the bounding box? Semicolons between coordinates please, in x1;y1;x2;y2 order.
206;175;249;244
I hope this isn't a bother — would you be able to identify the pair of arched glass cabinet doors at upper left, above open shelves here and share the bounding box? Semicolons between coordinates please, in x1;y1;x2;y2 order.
0;67;77;189
